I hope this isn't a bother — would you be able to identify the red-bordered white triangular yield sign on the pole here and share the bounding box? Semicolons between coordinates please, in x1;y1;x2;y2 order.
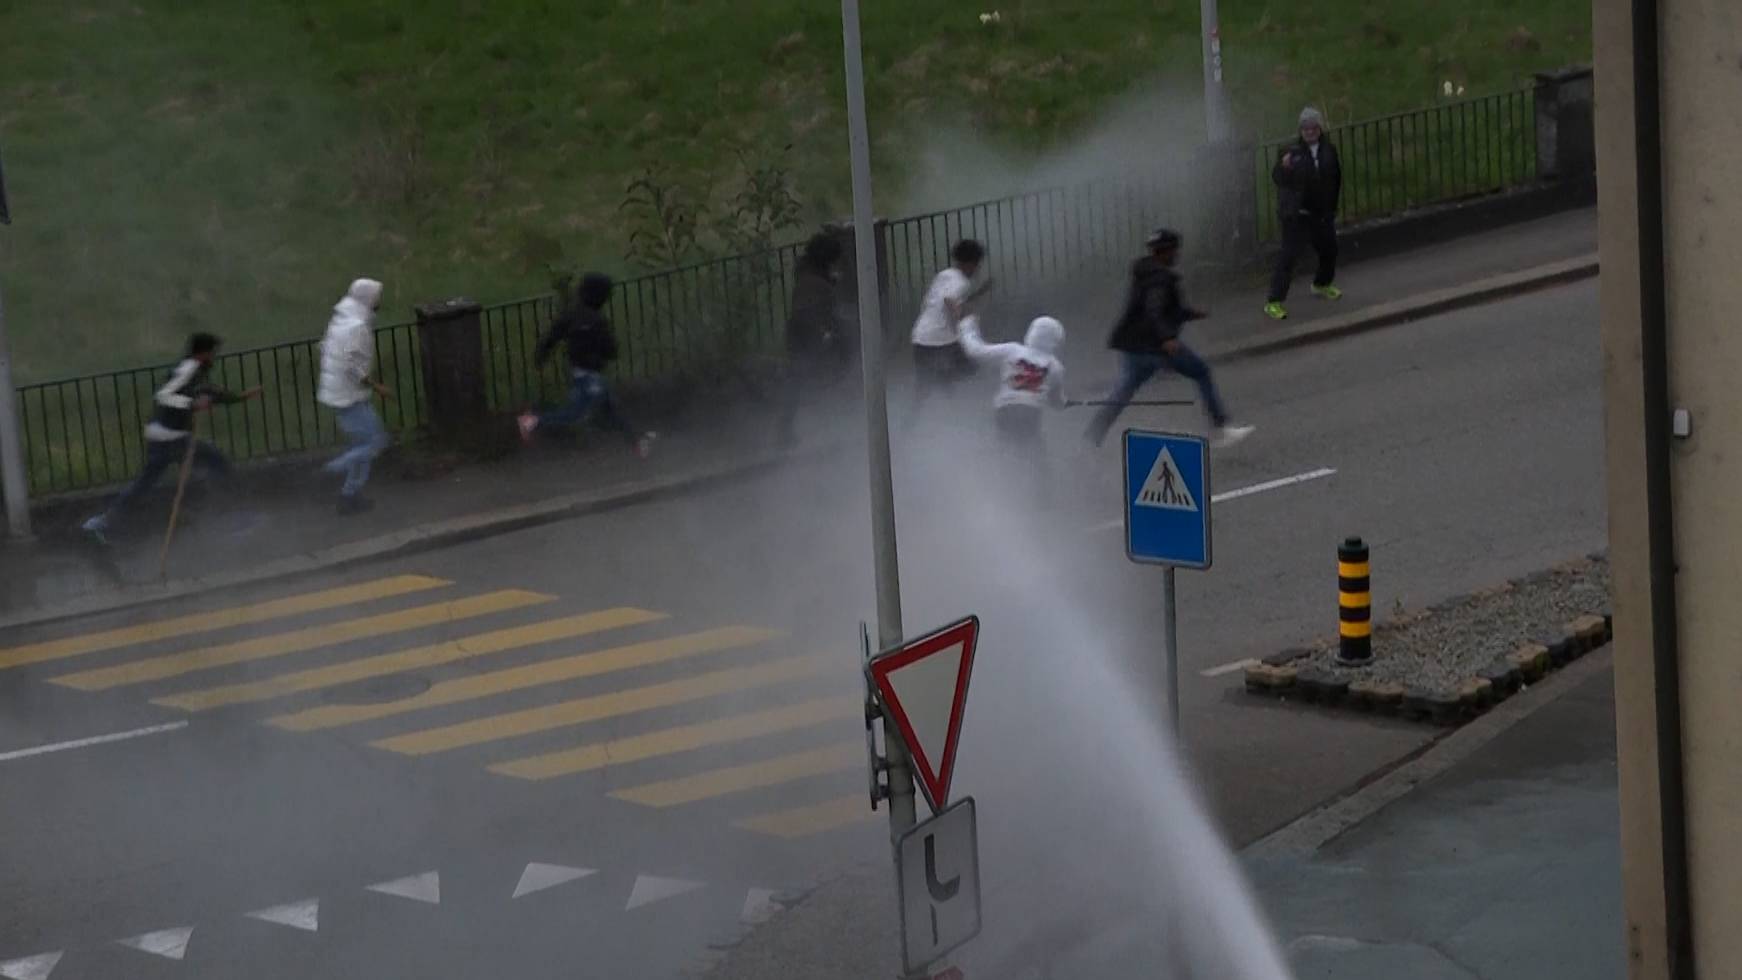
866;616;979;813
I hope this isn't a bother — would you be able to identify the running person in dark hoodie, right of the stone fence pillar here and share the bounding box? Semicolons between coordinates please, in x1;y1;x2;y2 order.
521;272;655;460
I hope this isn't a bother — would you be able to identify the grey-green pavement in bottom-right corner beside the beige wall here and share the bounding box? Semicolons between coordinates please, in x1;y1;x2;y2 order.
1247;653;1627;980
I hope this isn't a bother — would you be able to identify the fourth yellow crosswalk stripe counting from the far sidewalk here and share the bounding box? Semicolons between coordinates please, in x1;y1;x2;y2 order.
267;627;780;731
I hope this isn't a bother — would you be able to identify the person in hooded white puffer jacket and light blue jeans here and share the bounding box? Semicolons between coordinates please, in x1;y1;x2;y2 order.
315;279;390;513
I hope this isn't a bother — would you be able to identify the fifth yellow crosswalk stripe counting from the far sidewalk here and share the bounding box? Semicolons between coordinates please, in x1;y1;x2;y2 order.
371;656;831;755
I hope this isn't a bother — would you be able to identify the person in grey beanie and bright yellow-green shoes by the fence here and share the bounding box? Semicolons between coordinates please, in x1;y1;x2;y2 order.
1265;106;1343;320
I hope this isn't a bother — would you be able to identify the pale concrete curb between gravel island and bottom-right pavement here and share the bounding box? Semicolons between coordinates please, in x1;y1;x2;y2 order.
1240;653;1613;862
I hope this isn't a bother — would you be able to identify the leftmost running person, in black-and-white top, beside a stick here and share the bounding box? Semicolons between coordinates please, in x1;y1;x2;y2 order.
82;334;261;545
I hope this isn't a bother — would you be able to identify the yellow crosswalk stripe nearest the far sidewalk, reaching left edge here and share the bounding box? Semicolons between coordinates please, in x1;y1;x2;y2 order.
0;574;453;670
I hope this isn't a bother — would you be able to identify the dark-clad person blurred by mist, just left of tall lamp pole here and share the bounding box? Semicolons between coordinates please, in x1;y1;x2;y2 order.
779;232;848;446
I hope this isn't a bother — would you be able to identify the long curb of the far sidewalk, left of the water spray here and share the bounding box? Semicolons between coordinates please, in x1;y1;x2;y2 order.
0;446;834;630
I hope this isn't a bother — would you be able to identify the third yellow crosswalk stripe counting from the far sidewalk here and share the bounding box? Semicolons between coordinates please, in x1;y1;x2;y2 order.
152;607;665;717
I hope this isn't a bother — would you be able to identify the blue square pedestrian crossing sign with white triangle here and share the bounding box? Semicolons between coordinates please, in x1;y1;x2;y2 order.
1125;428;1211;569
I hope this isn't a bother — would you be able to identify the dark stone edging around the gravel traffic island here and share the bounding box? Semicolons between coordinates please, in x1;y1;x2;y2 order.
1246;555;1613;726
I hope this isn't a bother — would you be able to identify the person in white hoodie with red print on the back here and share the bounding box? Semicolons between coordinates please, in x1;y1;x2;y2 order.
960;315;1064;501
